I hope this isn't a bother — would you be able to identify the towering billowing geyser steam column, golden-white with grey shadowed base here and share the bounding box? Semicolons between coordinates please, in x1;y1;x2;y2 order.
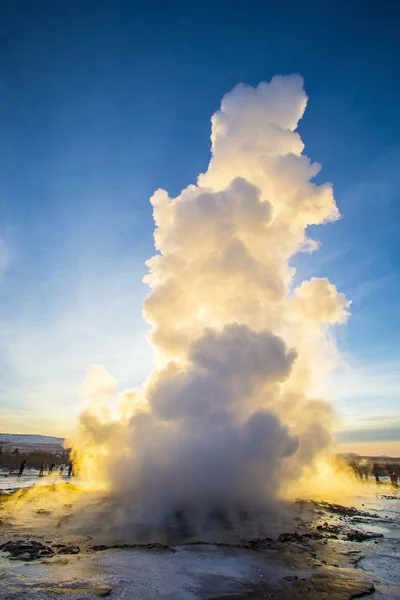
74;75;350;536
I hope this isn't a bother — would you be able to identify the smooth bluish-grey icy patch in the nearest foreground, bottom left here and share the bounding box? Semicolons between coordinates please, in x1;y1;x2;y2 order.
0;546;294;600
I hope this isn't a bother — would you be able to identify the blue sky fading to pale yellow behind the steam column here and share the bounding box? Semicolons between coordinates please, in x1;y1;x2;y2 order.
0;0;400;453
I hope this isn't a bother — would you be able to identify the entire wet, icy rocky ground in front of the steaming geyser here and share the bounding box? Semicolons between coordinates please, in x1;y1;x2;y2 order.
0;479;400;600
